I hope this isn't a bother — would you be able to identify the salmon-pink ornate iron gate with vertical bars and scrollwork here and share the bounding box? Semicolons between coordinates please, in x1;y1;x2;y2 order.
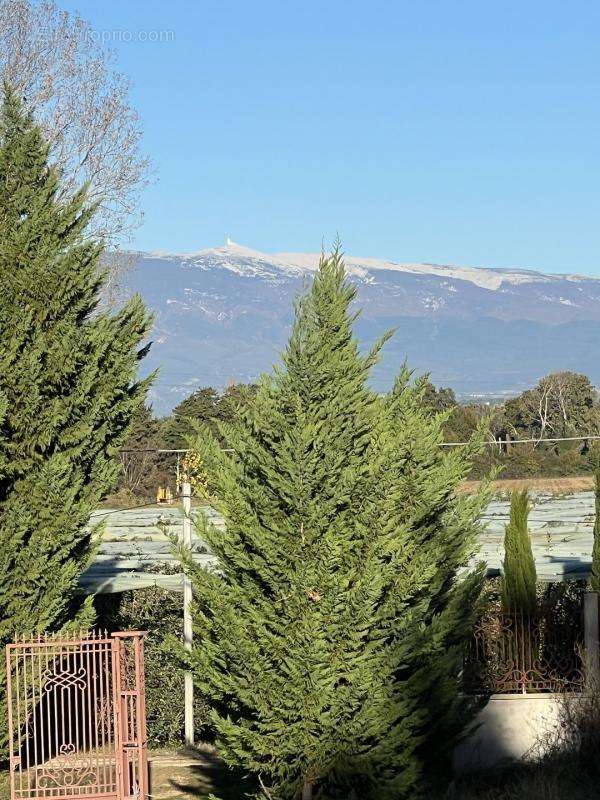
6;631;147;800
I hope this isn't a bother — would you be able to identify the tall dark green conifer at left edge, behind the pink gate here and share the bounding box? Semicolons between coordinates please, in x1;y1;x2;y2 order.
0;88;150;752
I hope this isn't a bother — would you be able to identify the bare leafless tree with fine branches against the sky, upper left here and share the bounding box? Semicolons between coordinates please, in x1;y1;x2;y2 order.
0;0;149;294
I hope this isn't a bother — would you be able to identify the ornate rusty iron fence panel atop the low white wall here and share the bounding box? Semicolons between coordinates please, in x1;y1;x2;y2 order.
463;611;584;694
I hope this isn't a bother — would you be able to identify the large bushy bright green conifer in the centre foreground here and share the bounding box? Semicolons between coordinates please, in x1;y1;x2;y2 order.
186;251;490;800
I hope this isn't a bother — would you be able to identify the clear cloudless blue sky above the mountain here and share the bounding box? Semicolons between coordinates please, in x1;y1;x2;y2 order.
58;0;600;275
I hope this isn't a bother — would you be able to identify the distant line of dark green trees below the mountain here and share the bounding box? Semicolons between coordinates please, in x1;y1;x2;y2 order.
119;372;600;499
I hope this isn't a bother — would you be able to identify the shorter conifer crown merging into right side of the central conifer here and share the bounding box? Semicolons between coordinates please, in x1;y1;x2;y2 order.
373;368;490;800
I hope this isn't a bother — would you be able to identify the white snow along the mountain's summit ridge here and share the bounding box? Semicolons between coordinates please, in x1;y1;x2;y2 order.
143;244;600;291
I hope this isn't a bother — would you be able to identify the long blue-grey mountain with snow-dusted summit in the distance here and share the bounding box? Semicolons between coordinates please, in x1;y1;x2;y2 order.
124;240;600;414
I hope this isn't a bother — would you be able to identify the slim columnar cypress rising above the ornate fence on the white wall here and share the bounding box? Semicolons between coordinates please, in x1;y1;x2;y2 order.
502;490;537;611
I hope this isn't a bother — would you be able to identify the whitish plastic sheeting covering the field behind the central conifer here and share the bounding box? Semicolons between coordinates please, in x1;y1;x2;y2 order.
81;492;594;594
